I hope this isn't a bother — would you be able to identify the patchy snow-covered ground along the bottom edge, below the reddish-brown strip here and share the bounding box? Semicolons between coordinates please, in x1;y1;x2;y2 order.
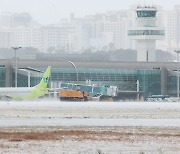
2;140;179;154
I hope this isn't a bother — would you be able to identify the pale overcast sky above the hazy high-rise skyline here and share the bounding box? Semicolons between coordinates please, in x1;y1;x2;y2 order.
0;0;180;24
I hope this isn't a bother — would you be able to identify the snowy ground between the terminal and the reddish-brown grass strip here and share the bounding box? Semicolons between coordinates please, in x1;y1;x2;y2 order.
0;100;180;126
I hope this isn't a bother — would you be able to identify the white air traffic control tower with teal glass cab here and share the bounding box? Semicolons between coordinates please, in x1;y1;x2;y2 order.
128;6;165;62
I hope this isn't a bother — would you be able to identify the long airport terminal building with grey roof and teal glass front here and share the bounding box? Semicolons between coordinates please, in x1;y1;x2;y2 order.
0;60;179;98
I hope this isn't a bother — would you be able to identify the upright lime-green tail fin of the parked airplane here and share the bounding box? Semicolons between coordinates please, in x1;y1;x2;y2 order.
37;66;51;89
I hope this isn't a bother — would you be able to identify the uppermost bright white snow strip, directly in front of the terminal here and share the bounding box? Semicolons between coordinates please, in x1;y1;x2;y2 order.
0;99;180;109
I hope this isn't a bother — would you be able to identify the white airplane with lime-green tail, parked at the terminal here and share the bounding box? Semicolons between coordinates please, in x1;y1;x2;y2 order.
0;66;51;100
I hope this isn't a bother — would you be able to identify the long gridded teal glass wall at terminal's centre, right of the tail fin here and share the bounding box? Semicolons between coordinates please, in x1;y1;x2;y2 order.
51;68;137;91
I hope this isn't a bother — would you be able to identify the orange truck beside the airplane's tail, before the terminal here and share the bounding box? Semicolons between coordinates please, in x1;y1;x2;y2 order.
59;89;89;101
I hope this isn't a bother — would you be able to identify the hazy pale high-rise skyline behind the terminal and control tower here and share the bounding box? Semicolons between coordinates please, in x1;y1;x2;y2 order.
0;5;180;53
